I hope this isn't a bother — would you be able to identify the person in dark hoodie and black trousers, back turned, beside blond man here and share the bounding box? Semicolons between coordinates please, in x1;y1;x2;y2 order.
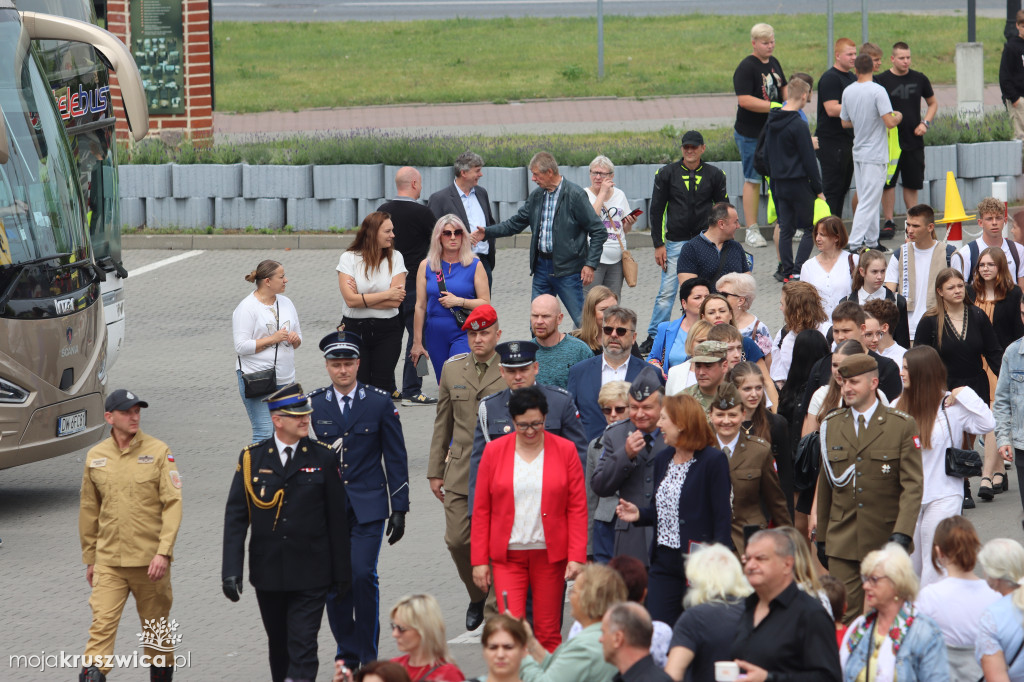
765;79;824;282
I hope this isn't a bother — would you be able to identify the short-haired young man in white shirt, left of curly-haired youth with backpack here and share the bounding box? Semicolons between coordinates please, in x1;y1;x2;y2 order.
886;204;953;341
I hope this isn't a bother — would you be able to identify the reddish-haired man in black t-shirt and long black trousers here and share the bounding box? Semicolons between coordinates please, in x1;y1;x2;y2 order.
814;38;857;218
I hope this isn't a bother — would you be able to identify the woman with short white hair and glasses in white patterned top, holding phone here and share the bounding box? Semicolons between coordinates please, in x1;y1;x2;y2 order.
584;156;636;300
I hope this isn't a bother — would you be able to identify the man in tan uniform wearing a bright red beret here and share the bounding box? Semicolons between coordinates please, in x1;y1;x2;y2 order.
427;305;506;630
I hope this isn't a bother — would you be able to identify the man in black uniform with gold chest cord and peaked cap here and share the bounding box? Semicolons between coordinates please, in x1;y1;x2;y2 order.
221;384;351;682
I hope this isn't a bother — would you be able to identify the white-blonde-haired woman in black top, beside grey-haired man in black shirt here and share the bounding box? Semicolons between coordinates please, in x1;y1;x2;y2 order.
665;544;754;682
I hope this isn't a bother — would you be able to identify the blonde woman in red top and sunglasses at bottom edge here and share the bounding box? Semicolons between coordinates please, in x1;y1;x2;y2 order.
391;594;466;682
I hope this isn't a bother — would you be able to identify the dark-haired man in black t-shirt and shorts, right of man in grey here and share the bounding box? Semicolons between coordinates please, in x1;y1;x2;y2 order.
874;42;939;239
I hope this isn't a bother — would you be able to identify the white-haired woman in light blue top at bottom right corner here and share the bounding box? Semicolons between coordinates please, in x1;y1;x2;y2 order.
974;538;1024;682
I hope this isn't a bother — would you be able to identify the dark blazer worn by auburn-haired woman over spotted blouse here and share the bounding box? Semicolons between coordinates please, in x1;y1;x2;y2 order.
636;447;733;553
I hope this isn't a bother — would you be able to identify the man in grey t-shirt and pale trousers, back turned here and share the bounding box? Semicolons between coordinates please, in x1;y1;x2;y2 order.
840;54;903;252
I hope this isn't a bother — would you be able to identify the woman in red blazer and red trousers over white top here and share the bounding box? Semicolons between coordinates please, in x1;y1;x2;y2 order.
470;386;587;651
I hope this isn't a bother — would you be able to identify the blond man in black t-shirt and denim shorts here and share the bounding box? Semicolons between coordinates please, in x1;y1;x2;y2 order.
732;24;786;247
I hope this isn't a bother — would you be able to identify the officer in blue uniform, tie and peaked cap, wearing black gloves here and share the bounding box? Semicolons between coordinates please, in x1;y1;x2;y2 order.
309;332;409;670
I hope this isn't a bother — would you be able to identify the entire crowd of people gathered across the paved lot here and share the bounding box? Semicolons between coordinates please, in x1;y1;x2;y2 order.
74;13;1024;682
